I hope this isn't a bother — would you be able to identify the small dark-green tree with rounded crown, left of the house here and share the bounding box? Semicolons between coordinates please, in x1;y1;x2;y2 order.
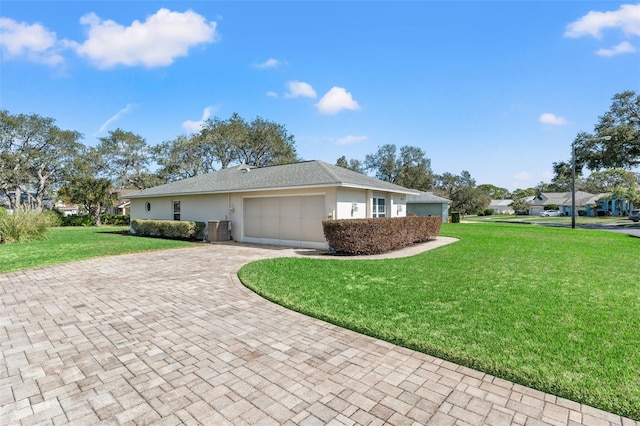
58;176;117;226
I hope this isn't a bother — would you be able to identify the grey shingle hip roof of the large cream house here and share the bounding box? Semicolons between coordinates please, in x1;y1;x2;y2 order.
126;160;418;198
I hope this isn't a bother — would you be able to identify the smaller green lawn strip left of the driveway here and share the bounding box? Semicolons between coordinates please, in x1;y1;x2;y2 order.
0;226;193;273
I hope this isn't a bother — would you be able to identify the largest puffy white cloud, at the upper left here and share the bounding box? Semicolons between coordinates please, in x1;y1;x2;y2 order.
76;8;216;68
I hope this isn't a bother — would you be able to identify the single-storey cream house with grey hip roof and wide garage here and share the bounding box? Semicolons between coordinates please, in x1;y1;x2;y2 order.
127;161;418;249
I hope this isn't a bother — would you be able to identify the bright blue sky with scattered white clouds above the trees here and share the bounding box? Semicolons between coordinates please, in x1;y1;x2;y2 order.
0;0;640;189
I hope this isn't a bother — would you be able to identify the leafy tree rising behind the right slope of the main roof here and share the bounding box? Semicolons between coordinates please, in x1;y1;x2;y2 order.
364;144;434;191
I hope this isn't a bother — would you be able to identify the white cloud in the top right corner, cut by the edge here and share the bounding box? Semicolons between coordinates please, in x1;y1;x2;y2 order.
564;4;640;38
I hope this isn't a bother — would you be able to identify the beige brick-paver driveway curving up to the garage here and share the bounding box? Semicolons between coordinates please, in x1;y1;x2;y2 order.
0;240;638;425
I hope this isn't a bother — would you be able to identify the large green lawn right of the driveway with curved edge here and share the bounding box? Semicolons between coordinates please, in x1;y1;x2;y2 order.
239;223;640;420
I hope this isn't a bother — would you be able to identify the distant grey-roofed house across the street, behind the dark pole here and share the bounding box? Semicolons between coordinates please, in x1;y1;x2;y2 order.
529;191;632;216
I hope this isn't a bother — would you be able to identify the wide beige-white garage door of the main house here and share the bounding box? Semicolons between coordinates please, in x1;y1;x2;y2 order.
243;195;327;248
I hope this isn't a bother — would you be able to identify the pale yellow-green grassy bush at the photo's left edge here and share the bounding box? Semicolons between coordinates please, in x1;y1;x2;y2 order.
0;208;55;244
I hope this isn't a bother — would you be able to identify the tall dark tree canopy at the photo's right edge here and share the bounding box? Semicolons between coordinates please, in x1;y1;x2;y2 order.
574;90;640;170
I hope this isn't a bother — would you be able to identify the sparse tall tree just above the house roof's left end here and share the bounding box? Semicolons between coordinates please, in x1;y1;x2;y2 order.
95;129;151;189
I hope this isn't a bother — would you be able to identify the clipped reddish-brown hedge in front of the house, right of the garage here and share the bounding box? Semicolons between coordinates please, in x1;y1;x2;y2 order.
322;216;441;255
